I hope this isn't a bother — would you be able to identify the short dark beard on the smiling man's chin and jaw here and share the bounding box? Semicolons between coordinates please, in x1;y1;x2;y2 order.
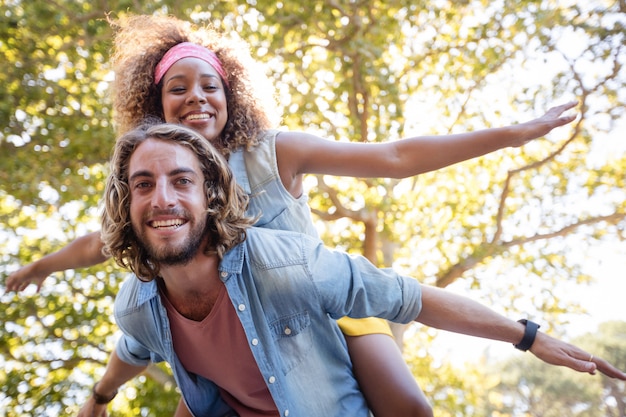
135;213;207;266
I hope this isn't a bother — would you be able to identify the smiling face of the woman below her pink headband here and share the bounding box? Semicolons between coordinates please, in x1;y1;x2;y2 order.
161;58;228;143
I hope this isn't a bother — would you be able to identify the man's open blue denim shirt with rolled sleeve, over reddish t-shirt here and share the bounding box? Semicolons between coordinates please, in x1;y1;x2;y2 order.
115;228;421;417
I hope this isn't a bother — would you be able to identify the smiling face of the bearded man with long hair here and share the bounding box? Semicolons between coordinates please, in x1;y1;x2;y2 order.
128;139;207;265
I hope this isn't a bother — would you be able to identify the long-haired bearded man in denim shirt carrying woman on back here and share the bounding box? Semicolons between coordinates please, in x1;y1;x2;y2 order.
79;124;626;417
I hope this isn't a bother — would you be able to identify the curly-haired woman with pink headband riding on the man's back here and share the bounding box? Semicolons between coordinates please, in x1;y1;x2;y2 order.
7;16;575;417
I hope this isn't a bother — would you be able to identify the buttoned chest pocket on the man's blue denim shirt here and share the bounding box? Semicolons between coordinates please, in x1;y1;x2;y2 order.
270;311;313;374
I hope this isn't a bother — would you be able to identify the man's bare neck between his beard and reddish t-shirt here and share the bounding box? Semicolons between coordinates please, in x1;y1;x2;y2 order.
161;250;223;321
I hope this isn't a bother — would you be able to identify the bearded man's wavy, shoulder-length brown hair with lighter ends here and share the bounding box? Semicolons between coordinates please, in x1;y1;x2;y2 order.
101;121;257;281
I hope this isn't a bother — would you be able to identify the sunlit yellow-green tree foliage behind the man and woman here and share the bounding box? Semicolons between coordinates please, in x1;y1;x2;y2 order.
0;0;626;416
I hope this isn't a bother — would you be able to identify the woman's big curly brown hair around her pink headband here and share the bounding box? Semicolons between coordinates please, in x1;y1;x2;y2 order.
109;15;278;155
